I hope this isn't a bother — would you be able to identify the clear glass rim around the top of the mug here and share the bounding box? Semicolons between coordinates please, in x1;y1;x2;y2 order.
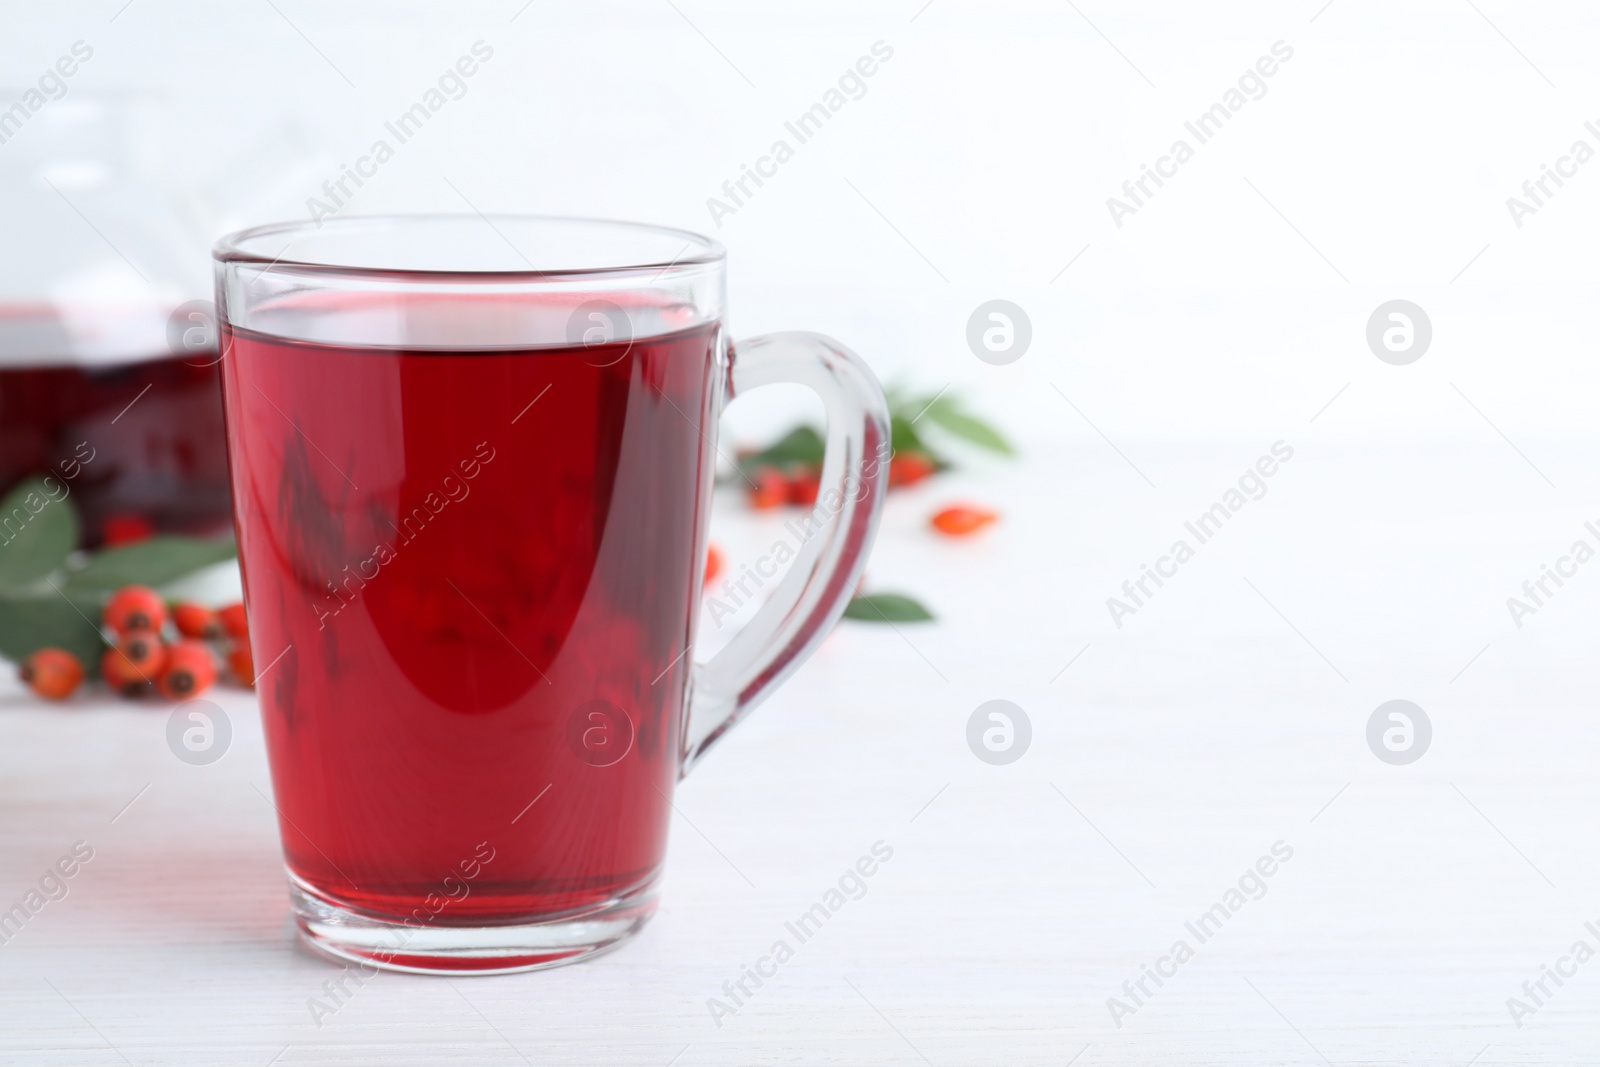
211;211;728;280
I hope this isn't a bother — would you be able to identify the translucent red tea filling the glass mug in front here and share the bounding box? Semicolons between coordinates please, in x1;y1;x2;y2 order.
224;315;718;926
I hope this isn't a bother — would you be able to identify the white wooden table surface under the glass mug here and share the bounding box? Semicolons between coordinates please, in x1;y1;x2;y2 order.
0;437;1600;1067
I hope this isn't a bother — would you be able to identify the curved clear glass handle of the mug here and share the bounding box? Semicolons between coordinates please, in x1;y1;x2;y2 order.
682;333;890;774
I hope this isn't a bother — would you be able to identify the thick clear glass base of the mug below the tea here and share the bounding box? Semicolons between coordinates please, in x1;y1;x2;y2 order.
290;875;656;974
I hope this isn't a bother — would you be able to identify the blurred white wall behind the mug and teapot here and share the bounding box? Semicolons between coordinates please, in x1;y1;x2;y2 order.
12;0;1597;454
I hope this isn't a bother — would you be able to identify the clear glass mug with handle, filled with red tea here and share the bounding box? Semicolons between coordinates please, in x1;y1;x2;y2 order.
214;216;890;973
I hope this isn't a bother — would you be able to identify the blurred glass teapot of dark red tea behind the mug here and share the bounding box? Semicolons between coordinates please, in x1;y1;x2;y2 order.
0;91;230;547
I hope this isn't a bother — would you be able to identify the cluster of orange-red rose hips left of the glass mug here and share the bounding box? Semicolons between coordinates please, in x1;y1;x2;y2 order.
19;585;256;701
